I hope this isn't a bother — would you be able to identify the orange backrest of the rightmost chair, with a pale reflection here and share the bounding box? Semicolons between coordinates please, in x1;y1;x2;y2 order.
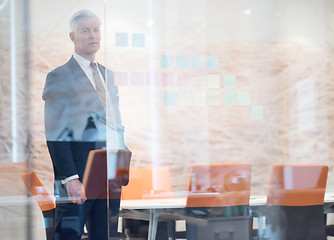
267;164;328;206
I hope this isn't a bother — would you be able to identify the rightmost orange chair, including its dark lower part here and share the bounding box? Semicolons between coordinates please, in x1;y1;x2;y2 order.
265;164;328;240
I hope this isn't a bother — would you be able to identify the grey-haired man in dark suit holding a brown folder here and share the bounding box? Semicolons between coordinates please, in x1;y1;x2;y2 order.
43;10;131;240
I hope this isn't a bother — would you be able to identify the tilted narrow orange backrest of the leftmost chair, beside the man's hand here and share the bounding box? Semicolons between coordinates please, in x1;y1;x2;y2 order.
21;172;56;212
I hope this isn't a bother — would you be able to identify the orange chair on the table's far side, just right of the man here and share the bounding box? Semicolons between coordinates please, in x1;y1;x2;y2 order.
122;167;175;239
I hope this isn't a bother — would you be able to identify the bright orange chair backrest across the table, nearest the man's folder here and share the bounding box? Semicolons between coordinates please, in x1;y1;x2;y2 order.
122;167;174;200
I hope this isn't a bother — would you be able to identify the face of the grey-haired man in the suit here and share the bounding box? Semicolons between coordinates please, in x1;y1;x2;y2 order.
70;17;101;57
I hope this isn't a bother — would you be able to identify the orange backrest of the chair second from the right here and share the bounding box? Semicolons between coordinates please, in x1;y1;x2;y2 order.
186;163;251;207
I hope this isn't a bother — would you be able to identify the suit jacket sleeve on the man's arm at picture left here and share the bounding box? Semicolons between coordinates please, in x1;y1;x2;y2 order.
43;71;77;179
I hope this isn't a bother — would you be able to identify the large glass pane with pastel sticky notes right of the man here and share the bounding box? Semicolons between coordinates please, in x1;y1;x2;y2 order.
106;1;333;194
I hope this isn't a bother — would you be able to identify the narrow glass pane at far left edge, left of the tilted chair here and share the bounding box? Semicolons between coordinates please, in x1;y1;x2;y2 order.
0;0;35;239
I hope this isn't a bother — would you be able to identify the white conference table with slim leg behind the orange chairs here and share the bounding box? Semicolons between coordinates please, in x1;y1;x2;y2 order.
120;192;334;240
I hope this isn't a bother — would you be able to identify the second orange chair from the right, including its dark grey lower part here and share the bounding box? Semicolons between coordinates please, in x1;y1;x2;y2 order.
181;163;251;240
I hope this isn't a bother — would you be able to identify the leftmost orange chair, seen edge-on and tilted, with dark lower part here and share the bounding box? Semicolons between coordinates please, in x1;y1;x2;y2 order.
21;172;56;240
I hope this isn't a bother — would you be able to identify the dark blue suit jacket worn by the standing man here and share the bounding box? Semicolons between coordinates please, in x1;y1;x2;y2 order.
43;57;126;180
